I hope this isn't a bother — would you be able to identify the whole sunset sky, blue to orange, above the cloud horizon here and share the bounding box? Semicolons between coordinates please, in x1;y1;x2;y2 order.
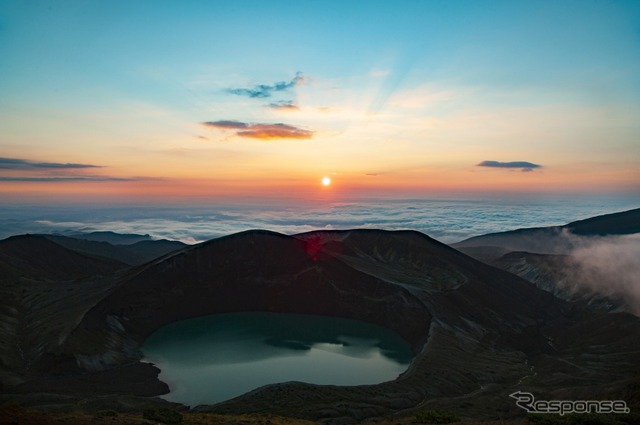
0;0;640;205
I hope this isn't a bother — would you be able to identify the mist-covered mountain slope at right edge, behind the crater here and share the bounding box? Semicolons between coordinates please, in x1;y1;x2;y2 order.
452;209;640;314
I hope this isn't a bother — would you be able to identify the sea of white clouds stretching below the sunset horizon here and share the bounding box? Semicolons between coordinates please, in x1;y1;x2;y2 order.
0;199;638;244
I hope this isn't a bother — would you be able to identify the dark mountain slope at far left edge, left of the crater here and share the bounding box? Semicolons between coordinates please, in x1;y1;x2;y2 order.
0;235;127;385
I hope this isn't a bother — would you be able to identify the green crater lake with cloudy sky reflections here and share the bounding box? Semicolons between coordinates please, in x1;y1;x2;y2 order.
142;313;413;406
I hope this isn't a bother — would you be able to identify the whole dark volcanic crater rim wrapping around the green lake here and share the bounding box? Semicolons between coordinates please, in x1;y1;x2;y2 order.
42;231;562;420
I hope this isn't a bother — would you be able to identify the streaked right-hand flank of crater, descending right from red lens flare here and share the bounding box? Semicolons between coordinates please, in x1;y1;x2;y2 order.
297;230;558;338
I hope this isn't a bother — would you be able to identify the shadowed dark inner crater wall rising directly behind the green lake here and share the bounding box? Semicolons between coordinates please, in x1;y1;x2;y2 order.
66;231;429;365
